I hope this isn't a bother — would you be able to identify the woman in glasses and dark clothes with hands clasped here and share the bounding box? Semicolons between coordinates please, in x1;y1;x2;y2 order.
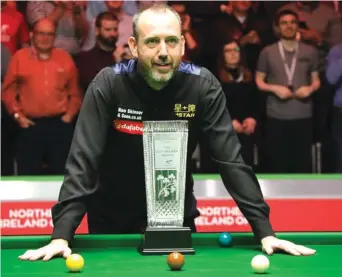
217;40;260;166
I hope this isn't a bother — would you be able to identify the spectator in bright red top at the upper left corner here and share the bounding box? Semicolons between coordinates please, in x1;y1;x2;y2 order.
1;1;30;54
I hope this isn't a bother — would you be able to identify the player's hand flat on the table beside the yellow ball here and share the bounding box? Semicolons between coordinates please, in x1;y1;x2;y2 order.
19;239;71;261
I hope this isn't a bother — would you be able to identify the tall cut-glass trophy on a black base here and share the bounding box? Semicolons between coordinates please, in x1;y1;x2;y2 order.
140;120;194;255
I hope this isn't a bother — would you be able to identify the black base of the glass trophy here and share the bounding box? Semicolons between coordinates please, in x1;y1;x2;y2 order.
138;227;195;255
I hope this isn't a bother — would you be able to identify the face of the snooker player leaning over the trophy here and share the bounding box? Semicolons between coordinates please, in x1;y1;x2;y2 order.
130;11;184;86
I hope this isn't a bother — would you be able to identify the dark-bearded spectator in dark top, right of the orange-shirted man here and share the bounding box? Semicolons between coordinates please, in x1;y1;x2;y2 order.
76;12;126;92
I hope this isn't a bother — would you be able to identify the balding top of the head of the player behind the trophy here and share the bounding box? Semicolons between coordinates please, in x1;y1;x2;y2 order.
132;3;182;39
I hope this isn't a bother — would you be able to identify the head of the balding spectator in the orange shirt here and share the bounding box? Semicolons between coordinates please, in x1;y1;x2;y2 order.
32;20;55;53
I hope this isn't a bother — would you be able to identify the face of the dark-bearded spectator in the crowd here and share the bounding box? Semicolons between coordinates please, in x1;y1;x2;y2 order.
96;19;119;48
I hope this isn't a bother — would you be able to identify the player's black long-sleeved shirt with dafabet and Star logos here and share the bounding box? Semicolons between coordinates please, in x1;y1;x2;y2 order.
52;59;273;241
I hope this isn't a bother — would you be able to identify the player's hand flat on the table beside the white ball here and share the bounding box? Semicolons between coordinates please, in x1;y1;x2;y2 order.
261;236;316;256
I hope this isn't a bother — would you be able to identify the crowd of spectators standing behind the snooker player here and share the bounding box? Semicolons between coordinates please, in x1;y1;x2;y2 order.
1;1;342;176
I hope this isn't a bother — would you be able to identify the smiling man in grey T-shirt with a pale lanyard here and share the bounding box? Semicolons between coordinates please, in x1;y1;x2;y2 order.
256;10;320;173
